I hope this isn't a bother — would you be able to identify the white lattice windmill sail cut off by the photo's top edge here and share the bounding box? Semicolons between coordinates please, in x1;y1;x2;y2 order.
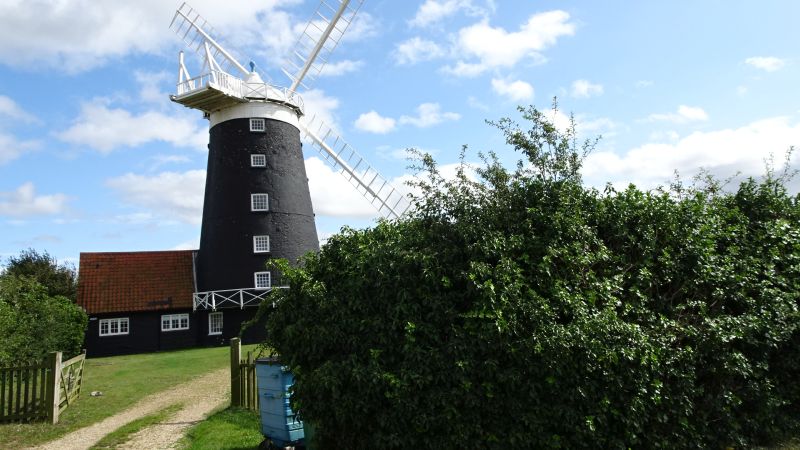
282;0;364;90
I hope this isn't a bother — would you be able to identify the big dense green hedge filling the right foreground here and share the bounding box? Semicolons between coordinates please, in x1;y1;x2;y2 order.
268;109;800;449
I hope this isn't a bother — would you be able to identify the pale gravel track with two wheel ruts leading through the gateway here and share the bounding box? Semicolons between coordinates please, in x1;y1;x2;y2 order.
36;368;230;450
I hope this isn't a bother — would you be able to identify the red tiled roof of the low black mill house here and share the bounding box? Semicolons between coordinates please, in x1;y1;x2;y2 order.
78;250;194;314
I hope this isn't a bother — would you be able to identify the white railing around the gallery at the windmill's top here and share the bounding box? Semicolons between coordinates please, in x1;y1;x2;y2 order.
177;70;304;114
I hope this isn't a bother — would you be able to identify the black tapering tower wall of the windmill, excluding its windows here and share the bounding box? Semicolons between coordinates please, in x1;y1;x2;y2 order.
197;118;319;291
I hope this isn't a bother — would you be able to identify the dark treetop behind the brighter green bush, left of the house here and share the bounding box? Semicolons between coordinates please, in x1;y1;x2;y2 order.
4;248;78;302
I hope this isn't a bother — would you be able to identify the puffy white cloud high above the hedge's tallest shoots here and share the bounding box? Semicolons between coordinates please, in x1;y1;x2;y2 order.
445;10;575;76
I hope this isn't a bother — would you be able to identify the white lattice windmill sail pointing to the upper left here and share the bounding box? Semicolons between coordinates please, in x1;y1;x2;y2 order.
169;2;249;75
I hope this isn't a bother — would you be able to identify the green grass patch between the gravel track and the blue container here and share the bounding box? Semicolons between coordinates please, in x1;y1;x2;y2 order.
179;408;264;450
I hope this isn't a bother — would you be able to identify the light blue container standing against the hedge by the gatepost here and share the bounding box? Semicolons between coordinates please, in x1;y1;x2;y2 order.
256;358;305;447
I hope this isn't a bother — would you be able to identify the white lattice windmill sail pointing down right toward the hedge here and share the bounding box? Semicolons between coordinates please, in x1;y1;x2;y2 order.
300;117;411;218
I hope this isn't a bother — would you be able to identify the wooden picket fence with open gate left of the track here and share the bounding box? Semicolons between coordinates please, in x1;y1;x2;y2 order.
0;350;86;423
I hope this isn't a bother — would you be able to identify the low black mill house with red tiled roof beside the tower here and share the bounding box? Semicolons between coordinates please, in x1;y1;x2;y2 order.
78;250;263;356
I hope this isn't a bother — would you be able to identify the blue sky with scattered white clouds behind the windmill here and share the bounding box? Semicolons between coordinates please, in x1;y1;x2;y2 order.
0;0;800;265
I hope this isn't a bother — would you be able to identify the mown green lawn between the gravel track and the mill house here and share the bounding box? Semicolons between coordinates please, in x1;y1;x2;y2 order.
0;346;255;449
